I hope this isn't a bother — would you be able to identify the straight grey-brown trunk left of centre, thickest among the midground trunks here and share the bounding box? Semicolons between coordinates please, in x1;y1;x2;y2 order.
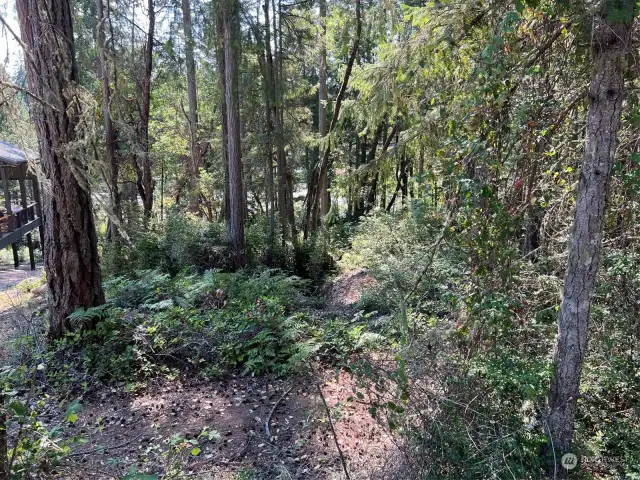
223;0;245;267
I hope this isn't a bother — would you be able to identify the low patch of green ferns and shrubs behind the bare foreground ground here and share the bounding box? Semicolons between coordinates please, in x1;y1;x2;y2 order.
37;270;378;390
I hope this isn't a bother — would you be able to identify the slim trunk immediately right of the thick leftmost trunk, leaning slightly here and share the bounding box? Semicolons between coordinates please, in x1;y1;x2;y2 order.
96;0;122;239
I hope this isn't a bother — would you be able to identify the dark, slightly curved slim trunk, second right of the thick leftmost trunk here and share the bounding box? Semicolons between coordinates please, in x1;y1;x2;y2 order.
136;0;156;218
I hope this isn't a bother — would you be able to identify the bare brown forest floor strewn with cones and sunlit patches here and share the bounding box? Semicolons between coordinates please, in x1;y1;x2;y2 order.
0;271;399;480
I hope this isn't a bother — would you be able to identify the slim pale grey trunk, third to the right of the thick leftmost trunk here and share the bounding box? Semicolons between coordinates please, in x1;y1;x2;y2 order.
182;0;202;212
